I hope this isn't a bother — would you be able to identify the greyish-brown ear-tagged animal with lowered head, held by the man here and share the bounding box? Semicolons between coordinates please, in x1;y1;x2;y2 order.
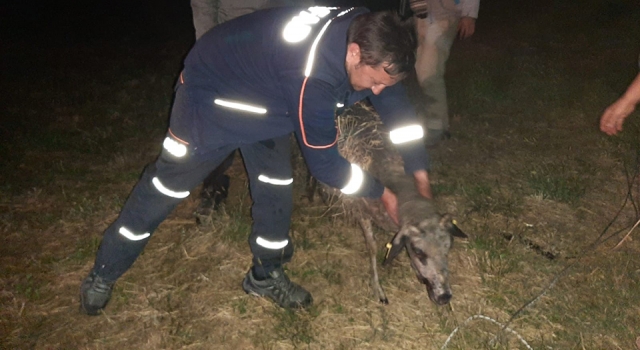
309;103;467;305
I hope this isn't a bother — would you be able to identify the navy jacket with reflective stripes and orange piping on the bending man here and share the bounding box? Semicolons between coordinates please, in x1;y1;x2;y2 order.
172;8;428;198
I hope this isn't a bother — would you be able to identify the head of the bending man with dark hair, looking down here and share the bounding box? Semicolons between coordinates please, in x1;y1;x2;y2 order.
345;11;416;95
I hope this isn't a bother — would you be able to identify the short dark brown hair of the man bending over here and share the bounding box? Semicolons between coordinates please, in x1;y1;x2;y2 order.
347;11;416;78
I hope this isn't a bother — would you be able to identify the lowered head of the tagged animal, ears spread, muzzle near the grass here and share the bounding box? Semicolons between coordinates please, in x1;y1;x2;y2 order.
384;215;467;305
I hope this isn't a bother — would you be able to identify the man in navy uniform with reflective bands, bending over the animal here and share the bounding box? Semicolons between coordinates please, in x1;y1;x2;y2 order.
81;7;431;315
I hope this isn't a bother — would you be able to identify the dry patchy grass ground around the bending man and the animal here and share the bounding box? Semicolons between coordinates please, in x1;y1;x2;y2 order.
0;0;640;350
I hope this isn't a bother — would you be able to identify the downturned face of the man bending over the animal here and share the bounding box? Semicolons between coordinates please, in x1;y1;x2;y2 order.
345;43;400;95
